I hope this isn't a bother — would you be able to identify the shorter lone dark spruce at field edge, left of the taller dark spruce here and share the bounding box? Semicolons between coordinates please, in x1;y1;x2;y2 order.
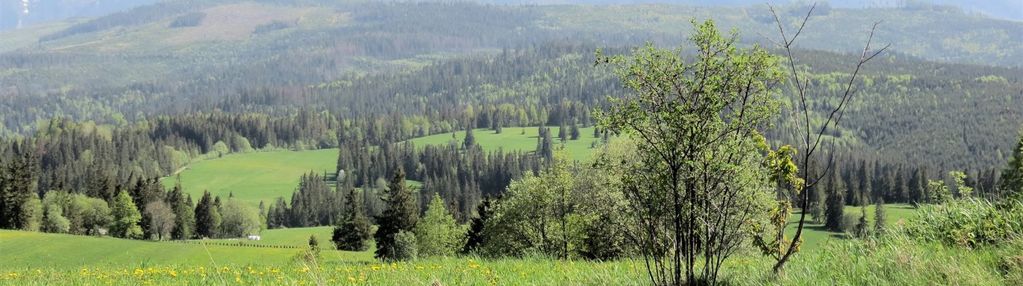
330;188;372;251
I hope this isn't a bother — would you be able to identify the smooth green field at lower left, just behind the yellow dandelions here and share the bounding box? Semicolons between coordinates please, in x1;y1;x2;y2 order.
0;227;373;269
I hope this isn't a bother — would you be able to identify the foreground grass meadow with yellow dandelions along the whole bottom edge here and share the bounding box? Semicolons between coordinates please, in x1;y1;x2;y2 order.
0;226;1010;285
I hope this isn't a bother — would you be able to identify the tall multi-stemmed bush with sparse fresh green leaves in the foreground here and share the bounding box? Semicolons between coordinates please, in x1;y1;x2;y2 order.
598;20;781;285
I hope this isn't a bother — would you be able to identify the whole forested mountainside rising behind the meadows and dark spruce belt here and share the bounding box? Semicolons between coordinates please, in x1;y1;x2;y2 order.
0;0;1023;169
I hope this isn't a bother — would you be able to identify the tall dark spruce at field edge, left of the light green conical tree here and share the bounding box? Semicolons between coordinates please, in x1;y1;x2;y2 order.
373;169;419;259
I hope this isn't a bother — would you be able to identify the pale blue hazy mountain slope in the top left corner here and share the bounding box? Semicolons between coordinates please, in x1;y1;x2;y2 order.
0;0;160;31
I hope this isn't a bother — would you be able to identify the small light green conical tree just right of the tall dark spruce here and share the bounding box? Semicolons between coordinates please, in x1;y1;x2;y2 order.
414;194;465;257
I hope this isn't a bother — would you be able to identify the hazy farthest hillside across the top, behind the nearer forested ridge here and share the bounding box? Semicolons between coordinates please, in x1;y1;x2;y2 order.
0;0;1023;133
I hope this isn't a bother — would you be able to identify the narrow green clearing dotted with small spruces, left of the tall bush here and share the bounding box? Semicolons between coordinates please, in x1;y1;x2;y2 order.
411;127;599;160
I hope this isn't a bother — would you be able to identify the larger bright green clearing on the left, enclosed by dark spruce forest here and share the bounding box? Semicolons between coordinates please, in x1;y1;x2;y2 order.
163;149;338;204
